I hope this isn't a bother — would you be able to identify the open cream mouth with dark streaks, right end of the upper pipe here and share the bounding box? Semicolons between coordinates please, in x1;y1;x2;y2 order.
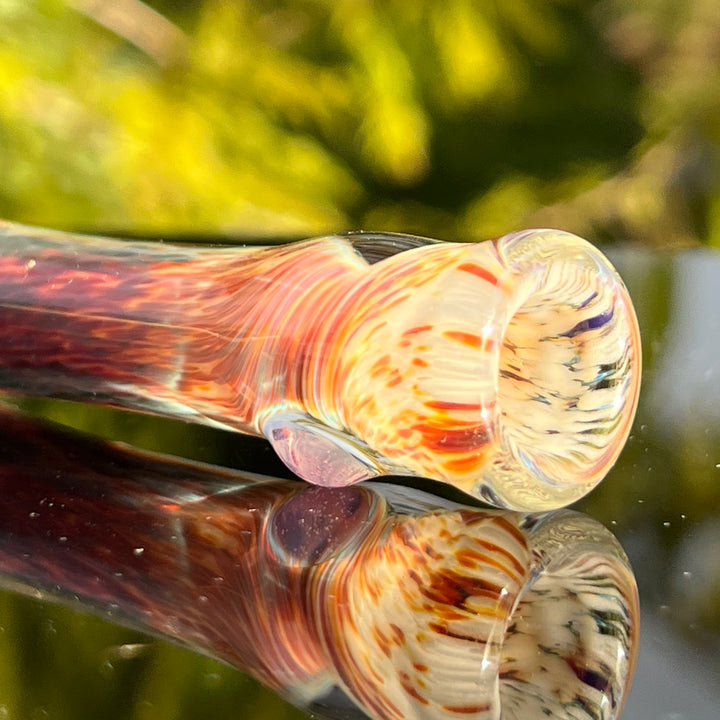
484;231;641;509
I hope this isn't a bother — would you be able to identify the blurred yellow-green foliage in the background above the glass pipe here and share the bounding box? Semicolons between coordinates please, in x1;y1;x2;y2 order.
0;0;720;246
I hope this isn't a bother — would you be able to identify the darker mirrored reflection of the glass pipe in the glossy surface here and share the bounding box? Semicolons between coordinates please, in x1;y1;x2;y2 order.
0;413;639;720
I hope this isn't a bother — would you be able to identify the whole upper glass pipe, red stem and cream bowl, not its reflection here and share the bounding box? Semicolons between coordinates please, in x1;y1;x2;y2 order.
0;223;641;510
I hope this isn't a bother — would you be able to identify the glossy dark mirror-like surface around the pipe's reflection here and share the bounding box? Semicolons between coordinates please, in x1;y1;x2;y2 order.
0;249;720;720
